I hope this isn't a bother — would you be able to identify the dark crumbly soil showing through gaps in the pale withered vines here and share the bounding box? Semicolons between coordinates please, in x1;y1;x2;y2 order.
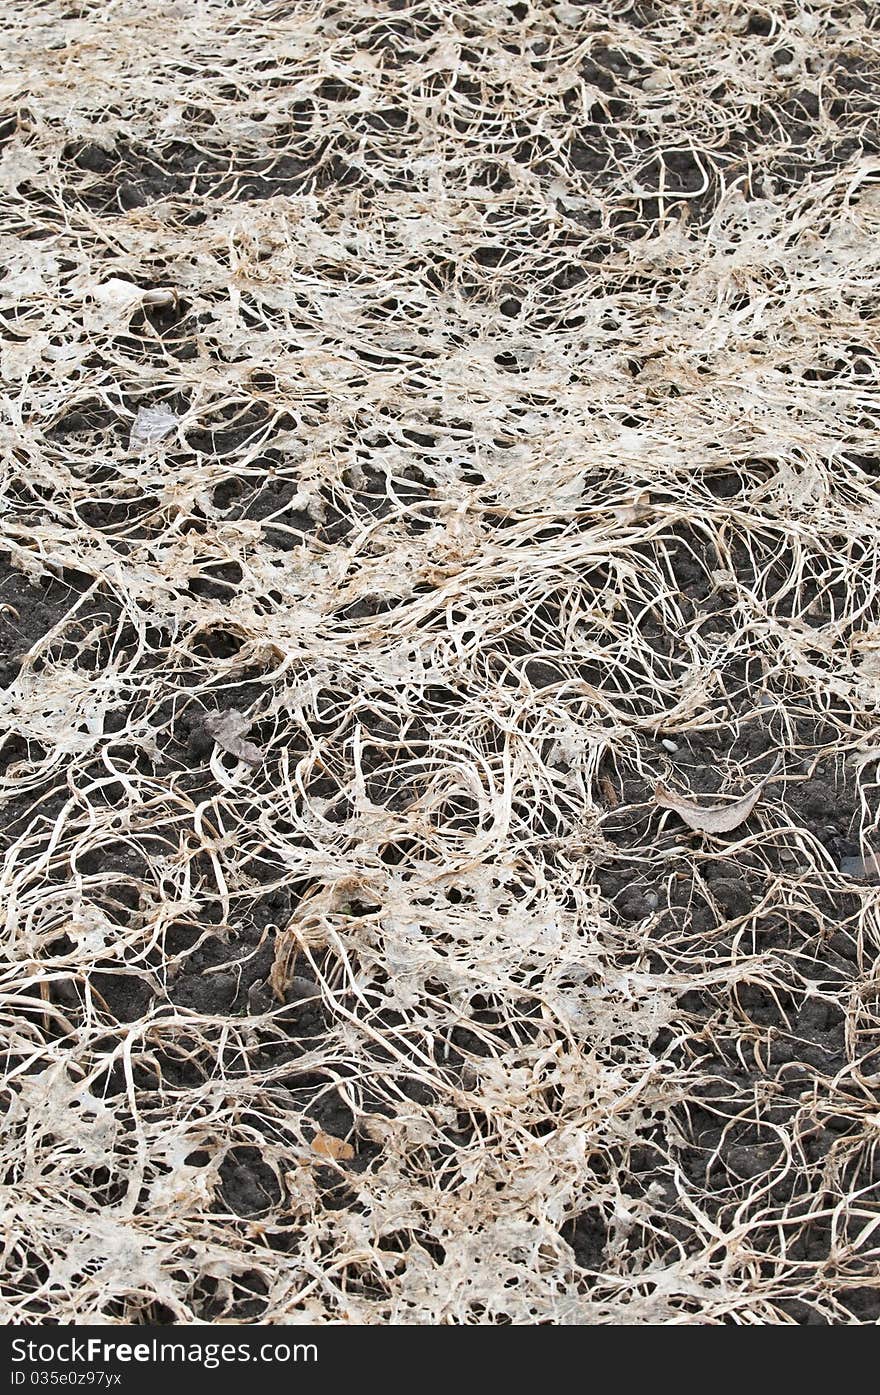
6;0;880;1325
